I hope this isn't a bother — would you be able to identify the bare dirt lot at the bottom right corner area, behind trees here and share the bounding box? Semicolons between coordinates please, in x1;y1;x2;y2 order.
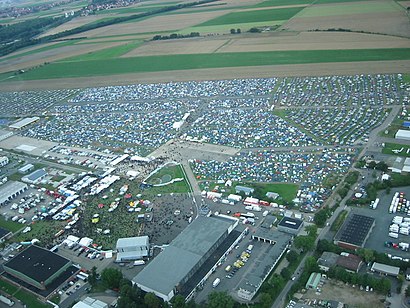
303;280;385;308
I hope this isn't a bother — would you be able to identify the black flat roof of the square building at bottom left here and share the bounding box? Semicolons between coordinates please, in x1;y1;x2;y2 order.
4;245;70;282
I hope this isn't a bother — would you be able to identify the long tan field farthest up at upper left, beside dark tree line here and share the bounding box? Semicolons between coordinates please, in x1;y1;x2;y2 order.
64;11;230;38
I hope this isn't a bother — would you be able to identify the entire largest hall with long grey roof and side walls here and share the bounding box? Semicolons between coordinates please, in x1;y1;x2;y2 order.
132;215;240;301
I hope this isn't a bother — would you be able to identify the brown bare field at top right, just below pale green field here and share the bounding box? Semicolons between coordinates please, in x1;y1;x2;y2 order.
281;1;410;37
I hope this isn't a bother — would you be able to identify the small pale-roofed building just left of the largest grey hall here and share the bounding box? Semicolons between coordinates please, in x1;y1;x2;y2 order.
116;236;149;262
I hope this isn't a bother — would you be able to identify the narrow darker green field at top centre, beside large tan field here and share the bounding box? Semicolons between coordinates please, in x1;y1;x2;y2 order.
198;7;303;26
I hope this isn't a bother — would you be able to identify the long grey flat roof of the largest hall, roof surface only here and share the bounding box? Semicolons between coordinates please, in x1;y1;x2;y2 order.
133;216;233;295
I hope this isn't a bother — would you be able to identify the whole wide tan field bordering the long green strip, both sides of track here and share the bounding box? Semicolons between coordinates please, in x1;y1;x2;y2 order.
124;32;410;57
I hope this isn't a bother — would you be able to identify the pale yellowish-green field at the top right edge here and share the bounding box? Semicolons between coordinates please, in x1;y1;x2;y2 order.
298;1;399;17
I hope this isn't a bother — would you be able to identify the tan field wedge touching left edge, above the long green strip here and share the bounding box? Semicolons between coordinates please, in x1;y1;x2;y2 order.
0;42;130;73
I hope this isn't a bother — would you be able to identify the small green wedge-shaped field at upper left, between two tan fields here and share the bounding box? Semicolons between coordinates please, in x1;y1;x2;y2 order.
59;41;142;62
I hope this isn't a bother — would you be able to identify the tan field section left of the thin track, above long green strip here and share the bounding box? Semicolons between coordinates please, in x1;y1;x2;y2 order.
123;38;228;57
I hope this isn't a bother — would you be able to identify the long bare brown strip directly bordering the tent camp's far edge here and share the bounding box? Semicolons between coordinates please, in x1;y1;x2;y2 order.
0;60;410;91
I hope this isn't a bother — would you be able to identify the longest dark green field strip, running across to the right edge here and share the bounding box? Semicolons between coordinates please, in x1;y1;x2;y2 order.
8;48;410;81
